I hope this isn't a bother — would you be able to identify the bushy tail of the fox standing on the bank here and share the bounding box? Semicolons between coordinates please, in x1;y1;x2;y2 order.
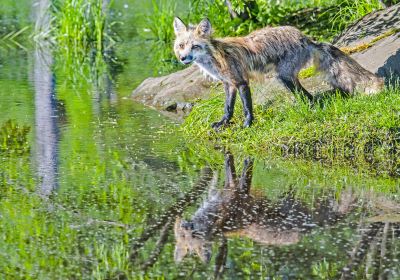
313;43;384;94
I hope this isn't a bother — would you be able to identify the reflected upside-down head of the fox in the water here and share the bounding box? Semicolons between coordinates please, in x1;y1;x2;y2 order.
174;218;212;263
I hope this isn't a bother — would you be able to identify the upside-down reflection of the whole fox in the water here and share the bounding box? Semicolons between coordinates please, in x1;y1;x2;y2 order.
174;152;352;262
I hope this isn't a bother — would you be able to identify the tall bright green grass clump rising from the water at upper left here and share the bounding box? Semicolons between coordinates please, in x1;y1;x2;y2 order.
47;0;116;84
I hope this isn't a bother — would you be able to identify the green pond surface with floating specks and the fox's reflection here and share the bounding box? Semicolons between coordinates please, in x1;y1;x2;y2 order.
0;1;400;279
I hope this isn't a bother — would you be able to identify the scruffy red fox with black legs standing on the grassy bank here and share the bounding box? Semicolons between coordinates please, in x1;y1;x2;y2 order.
173;17;383;129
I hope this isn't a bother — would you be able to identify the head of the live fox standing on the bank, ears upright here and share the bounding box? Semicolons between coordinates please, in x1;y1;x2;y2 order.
174;17;212;64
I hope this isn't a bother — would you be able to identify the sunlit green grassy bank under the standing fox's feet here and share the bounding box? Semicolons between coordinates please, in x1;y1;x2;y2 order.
182;87;400;175
